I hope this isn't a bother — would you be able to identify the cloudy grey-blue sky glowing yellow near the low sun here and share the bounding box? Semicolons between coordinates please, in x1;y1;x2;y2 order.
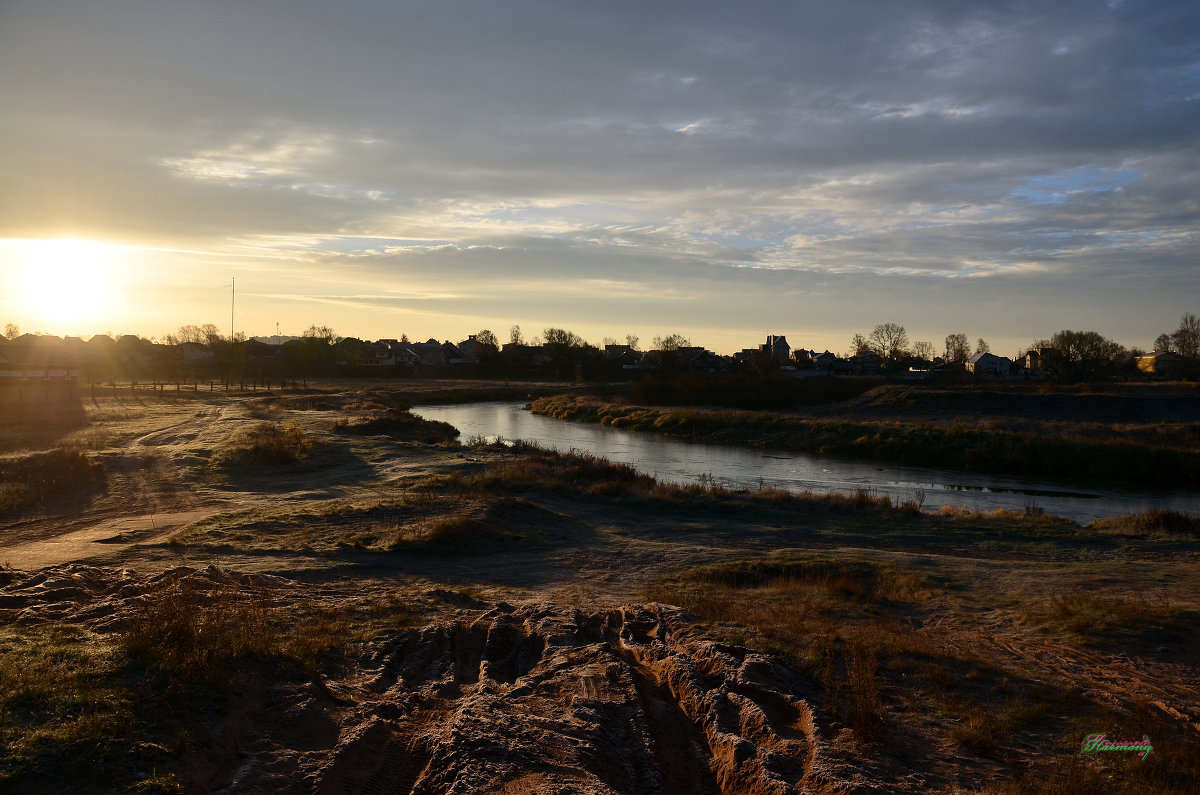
0;0;1200;355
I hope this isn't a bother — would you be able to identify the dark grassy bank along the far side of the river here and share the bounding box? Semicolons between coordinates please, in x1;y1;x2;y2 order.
532;395;1200;488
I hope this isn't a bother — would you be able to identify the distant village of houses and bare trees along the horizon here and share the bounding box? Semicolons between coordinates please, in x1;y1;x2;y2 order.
0;316;1196;384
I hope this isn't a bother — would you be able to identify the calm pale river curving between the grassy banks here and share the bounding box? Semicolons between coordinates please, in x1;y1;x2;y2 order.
413;402;1200;524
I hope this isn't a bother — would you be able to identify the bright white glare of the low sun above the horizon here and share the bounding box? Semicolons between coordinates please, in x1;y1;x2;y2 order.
13;239;119;329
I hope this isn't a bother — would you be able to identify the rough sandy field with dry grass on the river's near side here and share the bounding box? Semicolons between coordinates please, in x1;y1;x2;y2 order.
0;382;1200;794
